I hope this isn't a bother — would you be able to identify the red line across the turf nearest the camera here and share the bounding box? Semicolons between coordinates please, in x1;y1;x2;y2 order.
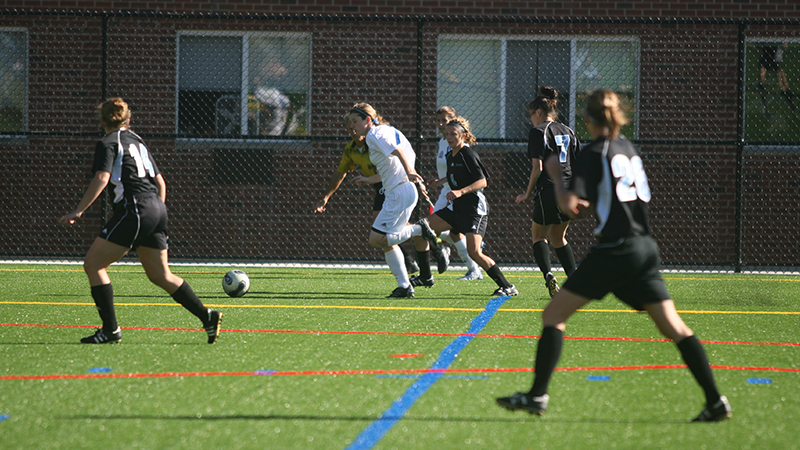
0;364;800;380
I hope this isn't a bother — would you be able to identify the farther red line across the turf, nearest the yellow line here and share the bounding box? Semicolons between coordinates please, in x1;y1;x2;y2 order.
0;323;800;348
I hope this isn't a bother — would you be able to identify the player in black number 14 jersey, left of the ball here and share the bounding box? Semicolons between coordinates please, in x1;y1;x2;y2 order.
59;98;222;344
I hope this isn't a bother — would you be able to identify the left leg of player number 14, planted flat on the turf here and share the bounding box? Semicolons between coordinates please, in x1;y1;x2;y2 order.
81;237;129;344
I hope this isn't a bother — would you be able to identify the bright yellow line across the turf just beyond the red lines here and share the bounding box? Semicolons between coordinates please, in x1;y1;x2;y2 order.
0;301;800;316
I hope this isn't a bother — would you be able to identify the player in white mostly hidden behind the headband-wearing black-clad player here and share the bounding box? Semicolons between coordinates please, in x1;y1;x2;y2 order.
427;106;483;281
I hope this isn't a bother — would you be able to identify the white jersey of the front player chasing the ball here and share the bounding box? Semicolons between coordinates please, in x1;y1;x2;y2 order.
367;125;417;191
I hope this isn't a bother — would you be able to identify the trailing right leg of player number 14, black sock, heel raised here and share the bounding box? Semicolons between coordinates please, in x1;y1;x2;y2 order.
136;246;222;344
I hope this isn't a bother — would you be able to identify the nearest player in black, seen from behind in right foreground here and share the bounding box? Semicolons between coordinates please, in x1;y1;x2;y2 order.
497;90;731;422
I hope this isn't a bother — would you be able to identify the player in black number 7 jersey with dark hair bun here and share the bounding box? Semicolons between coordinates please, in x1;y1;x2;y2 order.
516;86;581;297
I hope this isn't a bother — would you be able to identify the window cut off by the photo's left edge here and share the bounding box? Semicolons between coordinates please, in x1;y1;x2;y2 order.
0;28;28;133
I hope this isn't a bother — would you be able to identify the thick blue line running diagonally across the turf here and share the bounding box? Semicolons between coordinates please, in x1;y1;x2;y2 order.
347;296;510;450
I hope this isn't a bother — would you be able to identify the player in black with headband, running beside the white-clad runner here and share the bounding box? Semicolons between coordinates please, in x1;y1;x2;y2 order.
411;117;519;297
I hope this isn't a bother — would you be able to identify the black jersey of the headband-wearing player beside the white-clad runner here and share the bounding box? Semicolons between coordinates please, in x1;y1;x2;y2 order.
446;145;489;215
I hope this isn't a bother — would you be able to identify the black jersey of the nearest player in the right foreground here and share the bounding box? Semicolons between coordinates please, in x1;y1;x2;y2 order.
569;137;650;242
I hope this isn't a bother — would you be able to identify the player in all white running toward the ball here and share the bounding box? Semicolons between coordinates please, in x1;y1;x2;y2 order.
349;103;432;297
